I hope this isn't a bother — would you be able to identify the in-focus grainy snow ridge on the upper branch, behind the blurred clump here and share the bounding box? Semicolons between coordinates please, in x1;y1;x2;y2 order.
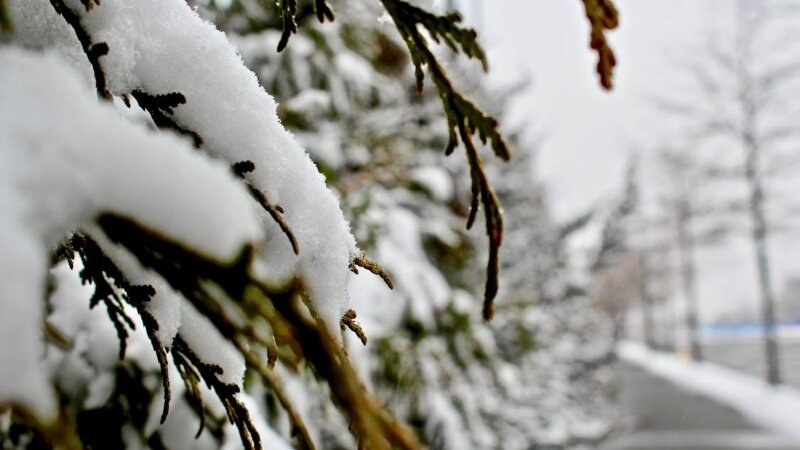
10;0;358;326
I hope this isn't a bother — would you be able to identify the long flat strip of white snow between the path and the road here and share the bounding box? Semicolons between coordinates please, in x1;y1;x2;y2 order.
617;342;800;439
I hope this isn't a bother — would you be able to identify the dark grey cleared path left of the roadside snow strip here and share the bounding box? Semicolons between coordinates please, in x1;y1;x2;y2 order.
600;362;800;450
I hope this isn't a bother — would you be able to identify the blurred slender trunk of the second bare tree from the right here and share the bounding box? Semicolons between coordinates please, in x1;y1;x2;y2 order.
677;199;703;361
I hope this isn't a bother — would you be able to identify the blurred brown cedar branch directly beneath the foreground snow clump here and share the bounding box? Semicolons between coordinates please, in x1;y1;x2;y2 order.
99;215;419;450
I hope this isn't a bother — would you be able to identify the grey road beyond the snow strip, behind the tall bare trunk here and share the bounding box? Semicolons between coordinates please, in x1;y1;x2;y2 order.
701;338;800;388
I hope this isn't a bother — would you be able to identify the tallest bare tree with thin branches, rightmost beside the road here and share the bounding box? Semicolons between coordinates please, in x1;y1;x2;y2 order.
656;0;800;384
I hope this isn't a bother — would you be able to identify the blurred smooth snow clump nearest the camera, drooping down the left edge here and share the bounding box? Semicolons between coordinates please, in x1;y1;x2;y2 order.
0;48;262;416
